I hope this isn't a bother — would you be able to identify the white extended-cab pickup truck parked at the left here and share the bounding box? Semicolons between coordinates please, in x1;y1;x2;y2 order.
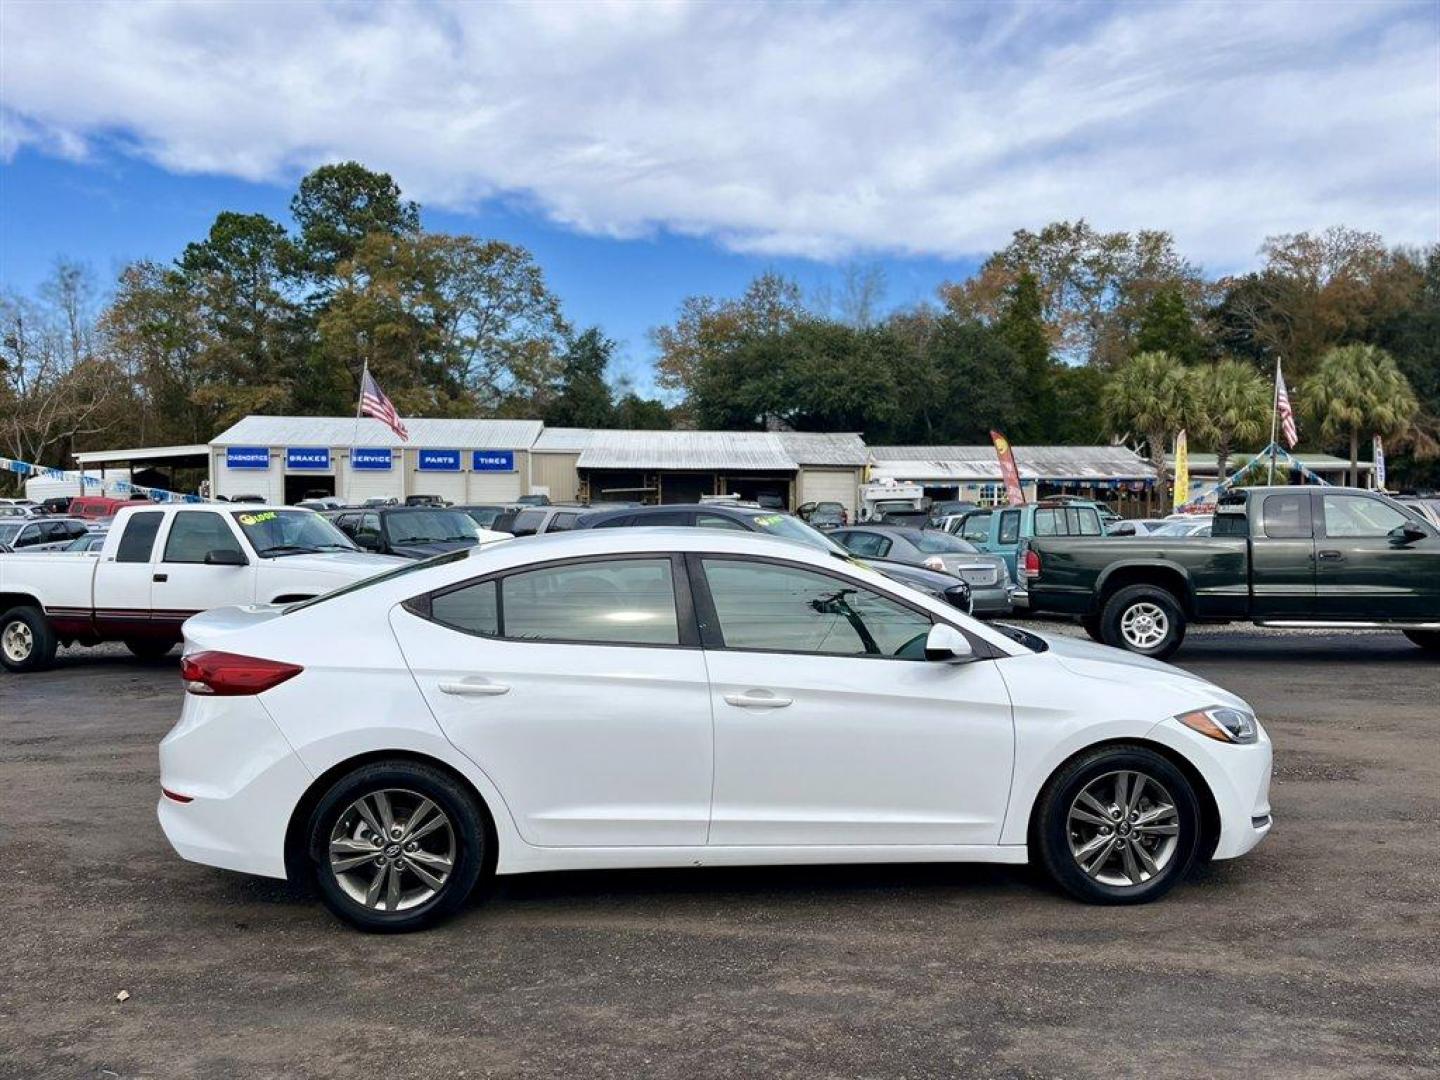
0;503;410;671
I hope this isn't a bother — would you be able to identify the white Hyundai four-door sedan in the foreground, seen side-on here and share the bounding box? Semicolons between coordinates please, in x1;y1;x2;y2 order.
160;528;1270;930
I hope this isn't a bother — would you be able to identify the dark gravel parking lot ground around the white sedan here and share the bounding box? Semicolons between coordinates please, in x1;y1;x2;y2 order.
0;629;1440;1080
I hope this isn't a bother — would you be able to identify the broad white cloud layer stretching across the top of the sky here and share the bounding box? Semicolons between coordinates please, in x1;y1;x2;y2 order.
0;3;1440;266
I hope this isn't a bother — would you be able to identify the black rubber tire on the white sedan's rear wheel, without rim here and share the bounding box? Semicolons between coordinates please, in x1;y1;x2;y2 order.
307;760;490;933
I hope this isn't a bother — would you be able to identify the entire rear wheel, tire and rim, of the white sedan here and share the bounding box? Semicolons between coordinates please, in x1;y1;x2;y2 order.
310;762;487;933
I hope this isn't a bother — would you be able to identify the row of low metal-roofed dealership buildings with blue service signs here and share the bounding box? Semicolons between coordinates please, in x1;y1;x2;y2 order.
64;416;1155;514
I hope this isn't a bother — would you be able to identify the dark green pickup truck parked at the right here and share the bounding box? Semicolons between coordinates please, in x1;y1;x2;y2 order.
1018;487;1440;658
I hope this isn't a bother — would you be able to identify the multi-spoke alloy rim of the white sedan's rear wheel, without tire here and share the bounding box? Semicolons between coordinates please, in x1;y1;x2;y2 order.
330;788;455;912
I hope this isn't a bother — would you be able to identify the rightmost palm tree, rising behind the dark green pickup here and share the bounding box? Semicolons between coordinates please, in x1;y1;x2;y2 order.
1300;346;1420;487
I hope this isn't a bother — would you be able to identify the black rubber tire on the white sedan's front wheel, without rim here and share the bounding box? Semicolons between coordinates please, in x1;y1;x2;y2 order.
1031;746;1200;904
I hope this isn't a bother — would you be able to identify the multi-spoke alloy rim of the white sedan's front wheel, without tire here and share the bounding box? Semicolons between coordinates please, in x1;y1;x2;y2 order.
1066;770;1179;887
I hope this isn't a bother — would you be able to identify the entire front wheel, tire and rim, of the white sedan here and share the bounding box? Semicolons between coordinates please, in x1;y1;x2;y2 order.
1034;746;1200;904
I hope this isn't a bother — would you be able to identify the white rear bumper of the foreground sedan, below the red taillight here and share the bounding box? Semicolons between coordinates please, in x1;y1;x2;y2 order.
157;694;312;877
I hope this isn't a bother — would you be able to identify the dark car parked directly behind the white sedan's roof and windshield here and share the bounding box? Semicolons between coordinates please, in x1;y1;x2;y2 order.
576;503;972;612
